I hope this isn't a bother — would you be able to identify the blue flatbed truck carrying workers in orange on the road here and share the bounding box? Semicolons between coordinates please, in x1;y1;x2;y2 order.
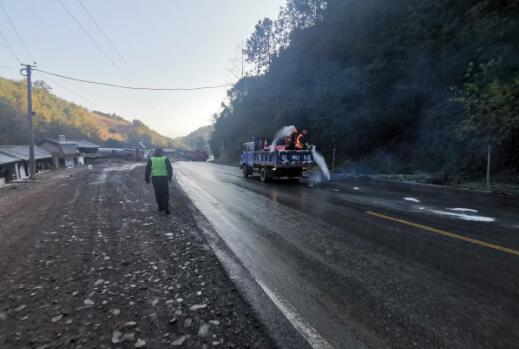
240;138;314;182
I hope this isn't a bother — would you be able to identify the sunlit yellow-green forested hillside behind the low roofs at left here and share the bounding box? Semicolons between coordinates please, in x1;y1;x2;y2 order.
0;78;178;147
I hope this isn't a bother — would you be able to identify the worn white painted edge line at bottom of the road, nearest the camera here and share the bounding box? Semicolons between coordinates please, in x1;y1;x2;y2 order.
256;280;334;349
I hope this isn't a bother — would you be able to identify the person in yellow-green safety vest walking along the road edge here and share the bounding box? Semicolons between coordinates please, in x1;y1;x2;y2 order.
145;148;173;214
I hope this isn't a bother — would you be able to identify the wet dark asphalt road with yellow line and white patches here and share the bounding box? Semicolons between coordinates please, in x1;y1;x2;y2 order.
174;162;519;348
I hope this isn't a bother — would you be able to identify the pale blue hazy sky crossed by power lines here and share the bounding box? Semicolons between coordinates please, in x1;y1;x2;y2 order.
0;0;285;137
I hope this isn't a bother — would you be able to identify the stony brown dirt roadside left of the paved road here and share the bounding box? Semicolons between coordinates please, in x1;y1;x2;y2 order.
0;165;274;349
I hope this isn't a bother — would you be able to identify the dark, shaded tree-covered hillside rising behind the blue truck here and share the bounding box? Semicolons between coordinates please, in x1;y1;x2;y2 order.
211;0;519;181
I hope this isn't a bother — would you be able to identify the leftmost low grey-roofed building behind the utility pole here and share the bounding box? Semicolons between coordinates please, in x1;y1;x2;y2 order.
0;145;53;185
